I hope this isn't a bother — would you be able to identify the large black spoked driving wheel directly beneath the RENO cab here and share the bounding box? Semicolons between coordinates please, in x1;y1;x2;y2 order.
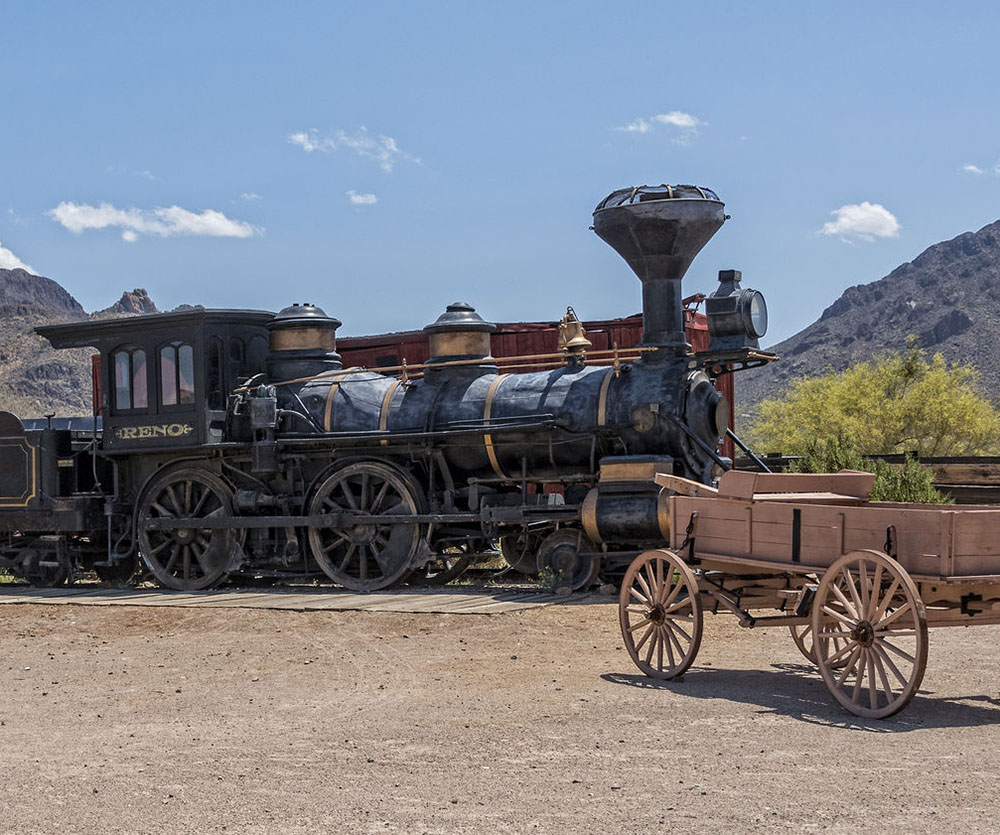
138;467;237;591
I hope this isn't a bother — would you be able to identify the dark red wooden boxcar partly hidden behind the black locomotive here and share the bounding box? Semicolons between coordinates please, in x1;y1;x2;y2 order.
337;310;735;457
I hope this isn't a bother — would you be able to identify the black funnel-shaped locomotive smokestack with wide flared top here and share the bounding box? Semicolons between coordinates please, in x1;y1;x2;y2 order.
594;185;726;354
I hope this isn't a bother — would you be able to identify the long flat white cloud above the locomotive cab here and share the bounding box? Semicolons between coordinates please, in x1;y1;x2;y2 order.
47;202;261;242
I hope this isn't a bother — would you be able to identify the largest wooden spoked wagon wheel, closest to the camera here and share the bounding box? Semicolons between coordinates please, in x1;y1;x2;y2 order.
812;551;927;719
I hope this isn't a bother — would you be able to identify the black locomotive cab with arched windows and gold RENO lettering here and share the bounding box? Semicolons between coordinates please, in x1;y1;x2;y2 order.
37;309;274;454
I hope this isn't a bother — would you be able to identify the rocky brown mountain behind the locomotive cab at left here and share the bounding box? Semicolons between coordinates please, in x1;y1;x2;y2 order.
0;269;157;417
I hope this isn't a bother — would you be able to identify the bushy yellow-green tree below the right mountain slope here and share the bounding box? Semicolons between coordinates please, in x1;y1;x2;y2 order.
746;339;1000;456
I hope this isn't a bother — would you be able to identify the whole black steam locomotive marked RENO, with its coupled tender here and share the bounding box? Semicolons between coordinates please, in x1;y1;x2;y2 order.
0;186;774;591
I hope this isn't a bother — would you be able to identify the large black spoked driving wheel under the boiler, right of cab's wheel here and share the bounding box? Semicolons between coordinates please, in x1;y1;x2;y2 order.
309;461;422;591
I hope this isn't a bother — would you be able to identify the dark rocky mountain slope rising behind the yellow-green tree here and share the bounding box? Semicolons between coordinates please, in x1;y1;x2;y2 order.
736;220;1000;414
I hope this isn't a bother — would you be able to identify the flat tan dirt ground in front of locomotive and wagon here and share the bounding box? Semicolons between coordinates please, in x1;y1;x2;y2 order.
0;603;1000;835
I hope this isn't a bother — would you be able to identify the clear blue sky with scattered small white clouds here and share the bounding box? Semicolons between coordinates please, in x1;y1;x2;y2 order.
0;0;1000;343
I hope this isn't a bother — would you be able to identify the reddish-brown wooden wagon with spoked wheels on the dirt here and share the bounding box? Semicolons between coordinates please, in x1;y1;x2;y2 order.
619;470;1000;718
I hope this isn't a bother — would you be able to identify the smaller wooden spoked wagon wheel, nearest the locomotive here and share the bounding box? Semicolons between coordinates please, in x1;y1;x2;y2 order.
618;549;702;679
